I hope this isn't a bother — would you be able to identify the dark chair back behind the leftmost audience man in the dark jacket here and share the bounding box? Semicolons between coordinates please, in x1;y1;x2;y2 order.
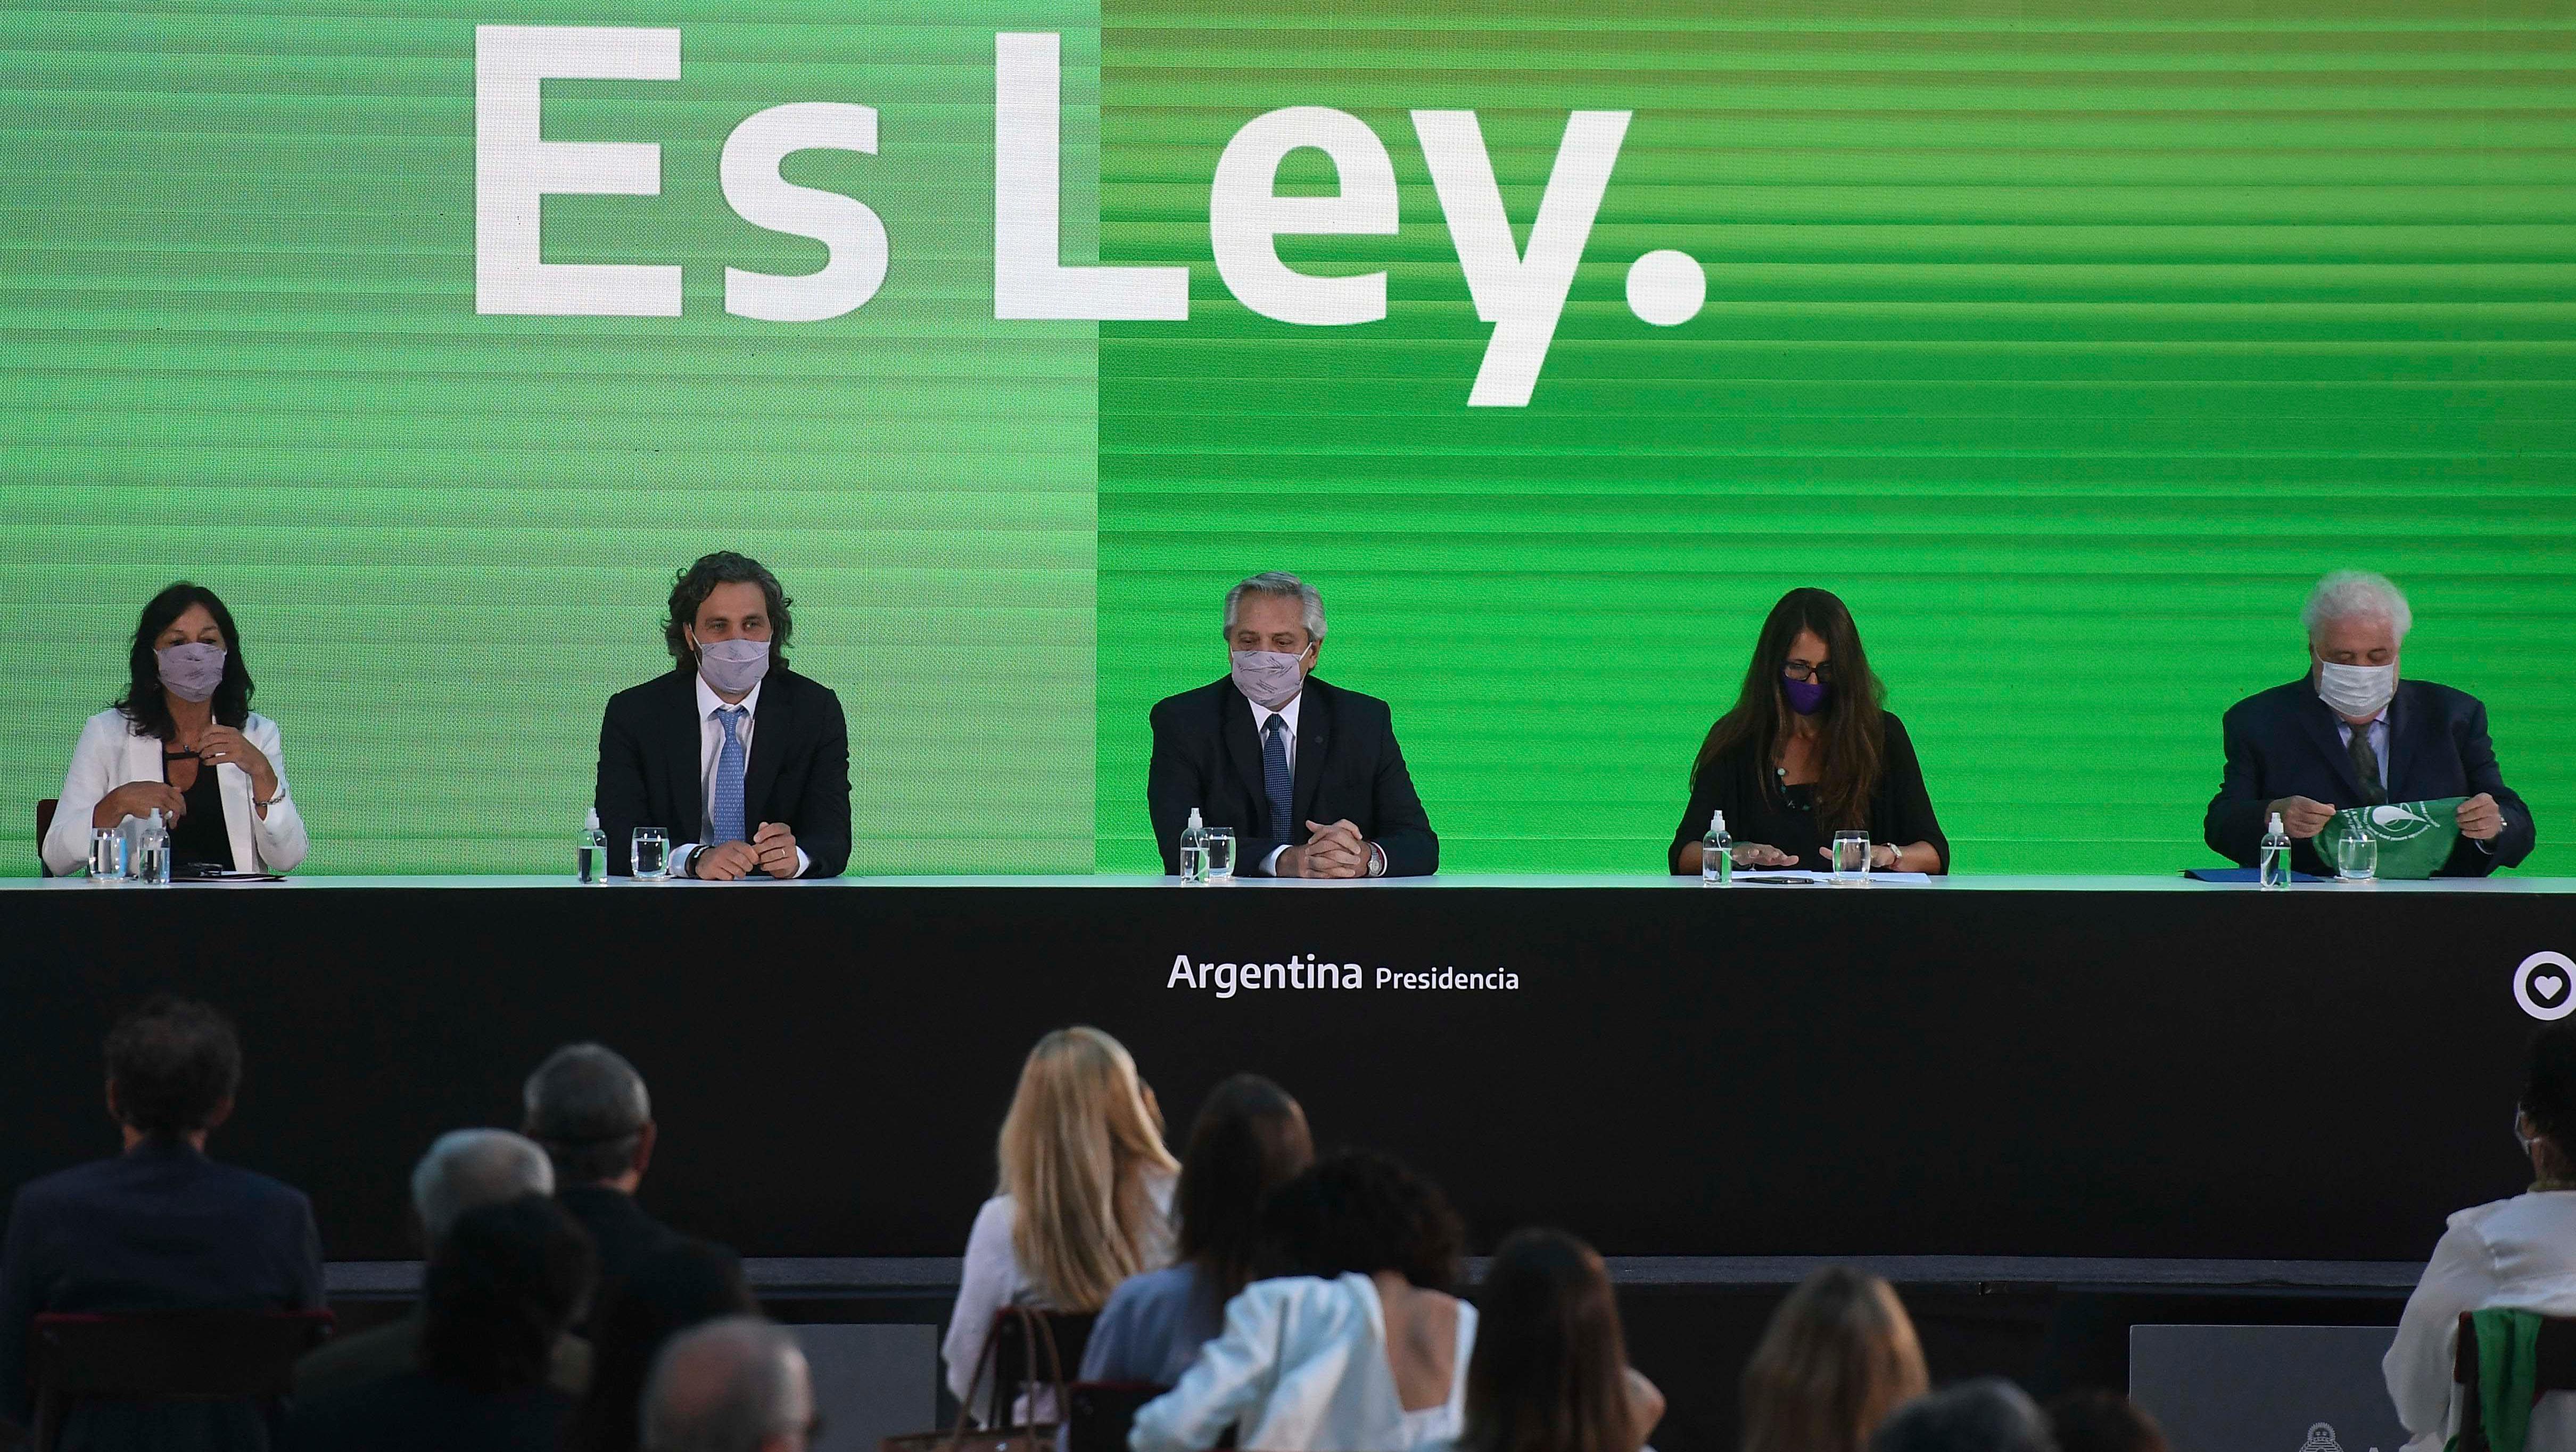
28;1310;332;1452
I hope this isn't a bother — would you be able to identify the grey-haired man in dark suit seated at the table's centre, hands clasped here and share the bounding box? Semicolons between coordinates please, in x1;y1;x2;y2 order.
1144;571;1440;878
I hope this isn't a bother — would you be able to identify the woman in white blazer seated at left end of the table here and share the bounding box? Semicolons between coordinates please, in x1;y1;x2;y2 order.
44;582;307;875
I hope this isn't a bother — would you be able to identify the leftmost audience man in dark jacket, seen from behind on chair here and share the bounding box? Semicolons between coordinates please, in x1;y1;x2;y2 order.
0;997;322;1447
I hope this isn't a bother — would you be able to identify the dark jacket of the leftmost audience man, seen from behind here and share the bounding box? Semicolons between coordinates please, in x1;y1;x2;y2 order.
0;1141;322;1444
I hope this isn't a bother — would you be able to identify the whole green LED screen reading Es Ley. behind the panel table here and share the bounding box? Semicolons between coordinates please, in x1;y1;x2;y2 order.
0;0;2576;873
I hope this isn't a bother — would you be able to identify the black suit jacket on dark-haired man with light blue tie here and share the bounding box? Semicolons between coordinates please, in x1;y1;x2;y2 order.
595;667;850;878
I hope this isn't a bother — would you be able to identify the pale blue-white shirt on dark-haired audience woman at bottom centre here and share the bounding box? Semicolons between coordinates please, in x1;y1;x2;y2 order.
1128;1274;1476;1452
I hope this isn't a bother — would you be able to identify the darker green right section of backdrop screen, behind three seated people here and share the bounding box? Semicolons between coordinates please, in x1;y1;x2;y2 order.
1100;0;2576;873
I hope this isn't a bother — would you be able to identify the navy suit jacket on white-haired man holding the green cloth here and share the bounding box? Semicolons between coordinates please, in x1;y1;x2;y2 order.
2200;677;2537;878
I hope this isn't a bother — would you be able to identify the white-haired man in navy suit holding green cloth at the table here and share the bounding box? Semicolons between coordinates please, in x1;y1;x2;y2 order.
2202;569;2535;878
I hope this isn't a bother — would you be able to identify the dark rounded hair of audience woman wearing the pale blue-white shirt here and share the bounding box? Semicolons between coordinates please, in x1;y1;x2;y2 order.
1254;1151;1466;1290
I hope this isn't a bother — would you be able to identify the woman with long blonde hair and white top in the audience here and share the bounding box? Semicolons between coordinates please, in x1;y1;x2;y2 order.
943;1027;1180;1406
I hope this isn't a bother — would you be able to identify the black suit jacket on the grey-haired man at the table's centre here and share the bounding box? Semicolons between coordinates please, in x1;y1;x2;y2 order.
1143;677;1440;878
